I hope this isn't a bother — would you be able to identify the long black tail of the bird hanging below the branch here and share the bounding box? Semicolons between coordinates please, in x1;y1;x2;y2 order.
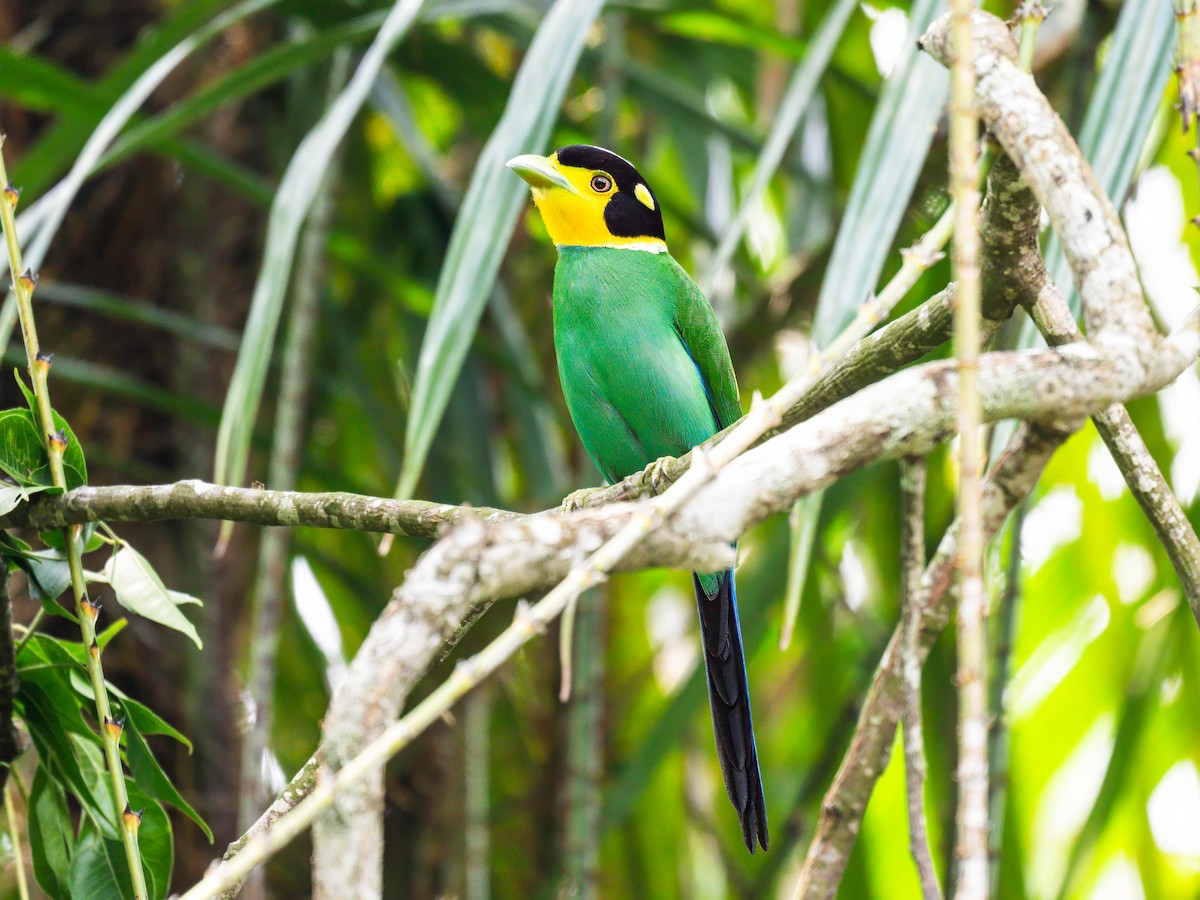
691;569;769;853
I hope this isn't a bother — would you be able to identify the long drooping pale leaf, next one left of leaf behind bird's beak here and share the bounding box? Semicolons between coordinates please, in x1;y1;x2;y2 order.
214;0;424;494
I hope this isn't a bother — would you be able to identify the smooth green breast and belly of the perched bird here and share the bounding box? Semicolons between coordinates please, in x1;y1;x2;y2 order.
554;247;718;481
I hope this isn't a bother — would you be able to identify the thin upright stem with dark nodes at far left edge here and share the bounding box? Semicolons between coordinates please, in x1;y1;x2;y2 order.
0;137;146;900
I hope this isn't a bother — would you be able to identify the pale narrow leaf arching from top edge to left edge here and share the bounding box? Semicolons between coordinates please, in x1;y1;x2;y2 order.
0;0;276;355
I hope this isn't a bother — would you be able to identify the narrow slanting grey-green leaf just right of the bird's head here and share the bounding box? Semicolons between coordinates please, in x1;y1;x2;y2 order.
700;0;858;300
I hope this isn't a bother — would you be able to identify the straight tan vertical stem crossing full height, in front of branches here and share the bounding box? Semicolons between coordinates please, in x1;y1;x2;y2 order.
949;0;988;900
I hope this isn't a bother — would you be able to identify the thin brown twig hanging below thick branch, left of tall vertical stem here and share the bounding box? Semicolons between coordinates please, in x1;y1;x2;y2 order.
900;458;942;900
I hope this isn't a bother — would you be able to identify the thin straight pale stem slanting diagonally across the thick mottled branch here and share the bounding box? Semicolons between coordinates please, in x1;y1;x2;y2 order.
182;254;926;900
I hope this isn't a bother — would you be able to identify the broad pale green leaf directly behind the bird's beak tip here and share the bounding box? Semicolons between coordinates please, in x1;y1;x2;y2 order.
396;0;604;497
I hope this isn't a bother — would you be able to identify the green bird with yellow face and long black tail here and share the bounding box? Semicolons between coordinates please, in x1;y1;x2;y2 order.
508;144;769;853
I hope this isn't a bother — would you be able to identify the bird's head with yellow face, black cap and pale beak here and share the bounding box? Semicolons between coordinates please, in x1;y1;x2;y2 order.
508;144;667;253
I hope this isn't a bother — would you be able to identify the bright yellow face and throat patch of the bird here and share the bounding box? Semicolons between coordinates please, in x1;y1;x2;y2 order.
533;154;666;250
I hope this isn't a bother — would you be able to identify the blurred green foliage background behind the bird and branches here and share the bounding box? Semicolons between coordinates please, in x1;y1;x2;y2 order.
0;0;1200;898
